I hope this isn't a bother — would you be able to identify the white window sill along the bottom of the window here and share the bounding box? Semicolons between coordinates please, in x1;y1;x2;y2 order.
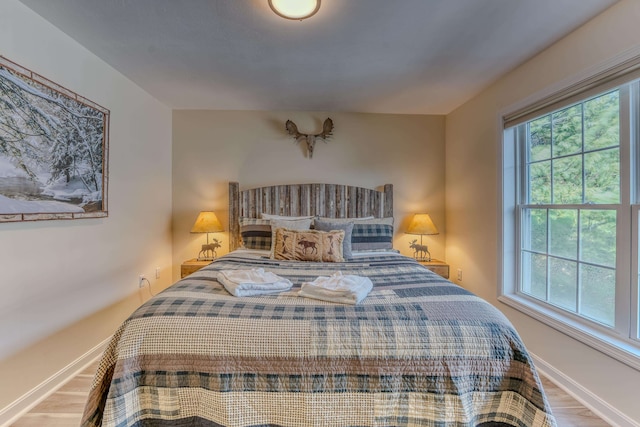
498;294;640;371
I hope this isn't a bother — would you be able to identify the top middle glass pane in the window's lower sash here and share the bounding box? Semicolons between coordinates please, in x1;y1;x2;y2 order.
549;209;578;259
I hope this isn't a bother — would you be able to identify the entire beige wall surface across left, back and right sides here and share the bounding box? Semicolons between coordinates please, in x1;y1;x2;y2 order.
5;0;640;420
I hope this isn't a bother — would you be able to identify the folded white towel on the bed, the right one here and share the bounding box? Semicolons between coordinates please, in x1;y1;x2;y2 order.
298;271;373;304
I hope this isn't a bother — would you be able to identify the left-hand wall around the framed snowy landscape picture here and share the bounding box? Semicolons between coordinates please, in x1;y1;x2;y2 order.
0;0;171;410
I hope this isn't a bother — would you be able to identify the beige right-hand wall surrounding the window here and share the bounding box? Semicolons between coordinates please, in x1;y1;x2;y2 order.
446;0;640;422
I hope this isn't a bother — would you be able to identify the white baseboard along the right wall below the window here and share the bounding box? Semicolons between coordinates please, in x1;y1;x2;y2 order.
529;353;640;427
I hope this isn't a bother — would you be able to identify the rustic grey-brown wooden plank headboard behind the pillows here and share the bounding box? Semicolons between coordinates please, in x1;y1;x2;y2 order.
229;182;393;251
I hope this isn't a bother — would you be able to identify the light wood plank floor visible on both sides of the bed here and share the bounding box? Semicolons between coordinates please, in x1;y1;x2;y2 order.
11;362;610;427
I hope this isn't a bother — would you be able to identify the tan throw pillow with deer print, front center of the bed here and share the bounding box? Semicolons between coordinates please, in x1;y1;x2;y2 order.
273;228;344;262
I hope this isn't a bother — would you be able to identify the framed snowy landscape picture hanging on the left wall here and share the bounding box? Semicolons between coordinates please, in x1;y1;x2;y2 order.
0;56;109;222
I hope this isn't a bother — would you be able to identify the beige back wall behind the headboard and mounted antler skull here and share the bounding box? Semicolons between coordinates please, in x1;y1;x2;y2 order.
173;110;445;277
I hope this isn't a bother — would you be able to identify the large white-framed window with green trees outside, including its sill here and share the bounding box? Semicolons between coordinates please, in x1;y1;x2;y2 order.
500;66;640;367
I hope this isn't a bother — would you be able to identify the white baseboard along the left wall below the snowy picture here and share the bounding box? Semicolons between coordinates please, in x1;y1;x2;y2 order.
0;338;111;427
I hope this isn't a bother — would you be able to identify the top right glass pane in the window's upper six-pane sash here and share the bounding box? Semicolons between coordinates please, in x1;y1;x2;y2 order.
584;90;620;150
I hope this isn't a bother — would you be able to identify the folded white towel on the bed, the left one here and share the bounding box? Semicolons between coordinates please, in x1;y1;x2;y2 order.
217;268;293;297
